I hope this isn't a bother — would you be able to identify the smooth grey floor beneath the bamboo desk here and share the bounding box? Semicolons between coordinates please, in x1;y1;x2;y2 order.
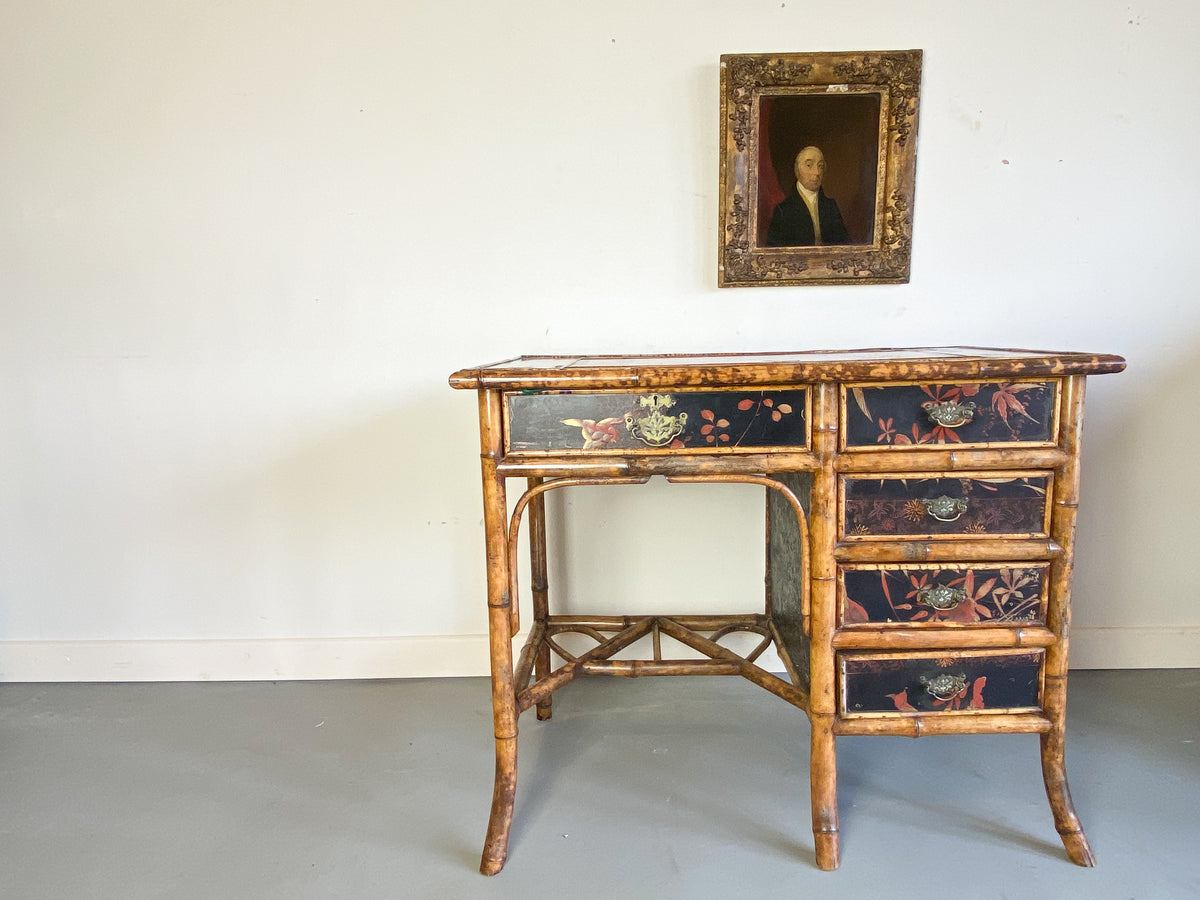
0;670;1200;900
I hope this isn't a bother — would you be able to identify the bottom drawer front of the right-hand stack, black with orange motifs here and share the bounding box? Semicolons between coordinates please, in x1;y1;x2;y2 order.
838;649;1044;716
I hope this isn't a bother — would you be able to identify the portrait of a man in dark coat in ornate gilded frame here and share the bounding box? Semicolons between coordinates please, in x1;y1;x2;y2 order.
718;50;920;287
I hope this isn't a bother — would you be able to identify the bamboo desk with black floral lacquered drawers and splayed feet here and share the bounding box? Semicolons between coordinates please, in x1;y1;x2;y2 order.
450;347;1124;875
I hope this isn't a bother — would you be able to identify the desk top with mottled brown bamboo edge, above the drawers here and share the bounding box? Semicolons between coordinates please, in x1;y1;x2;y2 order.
450;347;1124;390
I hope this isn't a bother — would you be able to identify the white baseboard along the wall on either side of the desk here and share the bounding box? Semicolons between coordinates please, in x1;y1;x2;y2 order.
0;625;1200;682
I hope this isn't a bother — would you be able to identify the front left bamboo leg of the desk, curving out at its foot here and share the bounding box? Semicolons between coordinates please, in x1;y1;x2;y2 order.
479;391;517;875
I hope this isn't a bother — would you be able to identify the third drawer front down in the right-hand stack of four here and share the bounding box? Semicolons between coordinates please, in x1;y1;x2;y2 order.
838;563;1050;629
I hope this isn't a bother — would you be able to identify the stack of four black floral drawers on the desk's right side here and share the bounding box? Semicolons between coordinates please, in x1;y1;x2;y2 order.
834;379;1073;733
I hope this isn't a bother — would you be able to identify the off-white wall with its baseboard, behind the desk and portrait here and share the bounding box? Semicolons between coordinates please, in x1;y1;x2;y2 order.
0;0;1200;680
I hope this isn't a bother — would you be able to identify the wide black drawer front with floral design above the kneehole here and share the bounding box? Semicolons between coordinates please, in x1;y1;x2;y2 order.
504;388;809;454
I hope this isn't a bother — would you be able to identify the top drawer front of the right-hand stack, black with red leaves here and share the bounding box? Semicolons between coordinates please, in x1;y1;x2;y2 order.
841;380;1058;449
